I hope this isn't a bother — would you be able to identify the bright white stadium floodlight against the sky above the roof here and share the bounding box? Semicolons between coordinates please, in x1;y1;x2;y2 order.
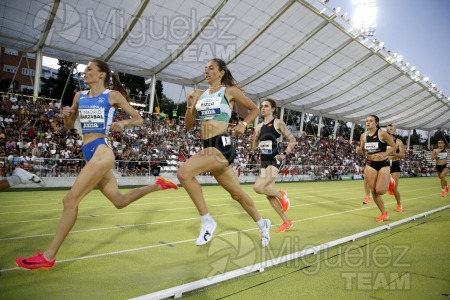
352;0;377;36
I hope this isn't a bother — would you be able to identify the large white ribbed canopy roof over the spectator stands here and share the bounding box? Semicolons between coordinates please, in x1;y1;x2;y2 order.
0;0;450;130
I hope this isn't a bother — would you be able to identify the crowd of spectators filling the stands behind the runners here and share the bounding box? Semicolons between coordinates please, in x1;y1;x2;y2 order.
0;94;434;180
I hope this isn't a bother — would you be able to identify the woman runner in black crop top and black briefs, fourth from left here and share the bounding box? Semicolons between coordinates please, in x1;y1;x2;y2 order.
356;115;397;222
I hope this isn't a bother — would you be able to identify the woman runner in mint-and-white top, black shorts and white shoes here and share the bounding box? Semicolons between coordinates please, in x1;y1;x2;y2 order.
177;58;270;247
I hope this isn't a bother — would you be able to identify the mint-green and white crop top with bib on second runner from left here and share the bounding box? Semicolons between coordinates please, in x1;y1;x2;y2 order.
195;86;231;123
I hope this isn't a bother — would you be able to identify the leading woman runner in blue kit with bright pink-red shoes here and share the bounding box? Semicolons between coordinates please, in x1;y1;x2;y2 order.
16;59;178;269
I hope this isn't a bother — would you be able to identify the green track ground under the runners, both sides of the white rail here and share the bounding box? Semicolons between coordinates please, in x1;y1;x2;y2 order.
0;177;450;300
